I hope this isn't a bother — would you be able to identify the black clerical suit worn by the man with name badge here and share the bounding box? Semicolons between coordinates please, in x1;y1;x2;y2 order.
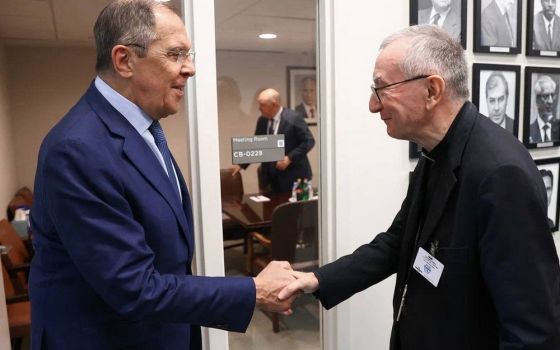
315;102;560;350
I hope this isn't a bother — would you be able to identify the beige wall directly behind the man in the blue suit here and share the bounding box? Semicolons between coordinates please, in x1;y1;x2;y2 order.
0;47;187;194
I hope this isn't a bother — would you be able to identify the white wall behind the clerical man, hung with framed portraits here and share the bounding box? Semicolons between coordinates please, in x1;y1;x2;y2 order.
329;0;560;350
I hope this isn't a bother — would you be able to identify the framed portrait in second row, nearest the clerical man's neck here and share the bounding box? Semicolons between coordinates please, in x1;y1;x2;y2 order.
472;63;521;137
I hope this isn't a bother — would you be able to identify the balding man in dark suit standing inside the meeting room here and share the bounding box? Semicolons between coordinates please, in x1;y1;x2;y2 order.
232;89;315;192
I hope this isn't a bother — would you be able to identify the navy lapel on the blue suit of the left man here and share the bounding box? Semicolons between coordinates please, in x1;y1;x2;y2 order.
86;83;191;245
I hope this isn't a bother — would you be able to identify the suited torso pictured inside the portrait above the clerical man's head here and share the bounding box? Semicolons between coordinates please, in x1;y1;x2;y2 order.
418;0;461;40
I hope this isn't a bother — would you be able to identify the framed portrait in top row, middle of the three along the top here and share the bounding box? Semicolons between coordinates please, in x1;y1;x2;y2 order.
473;0;522;54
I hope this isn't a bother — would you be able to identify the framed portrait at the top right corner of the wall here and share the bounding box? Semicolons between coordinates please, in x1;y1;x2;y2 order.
527;0;560;57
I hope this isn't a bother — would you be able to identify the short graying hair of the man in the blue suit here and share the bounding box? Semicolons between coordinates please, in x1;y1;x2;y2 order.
93;0;177;73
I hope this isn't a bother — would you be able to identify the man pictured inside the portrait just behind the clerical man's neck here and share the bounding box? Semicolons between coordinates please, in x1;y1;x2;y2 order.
486;71;513;133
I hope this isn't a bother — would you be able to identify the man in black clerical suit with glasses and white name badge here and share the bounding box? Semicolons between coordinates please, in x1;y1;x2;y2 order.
279;25;560;350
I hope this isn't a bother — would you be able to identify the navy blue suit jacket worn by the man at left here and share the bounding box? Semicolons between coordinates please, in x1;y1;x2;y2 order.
30;84;255;350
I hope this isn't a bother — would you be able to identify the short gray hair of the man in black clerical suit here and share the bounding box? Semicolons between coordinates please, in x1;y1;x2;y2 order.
379;24;469;100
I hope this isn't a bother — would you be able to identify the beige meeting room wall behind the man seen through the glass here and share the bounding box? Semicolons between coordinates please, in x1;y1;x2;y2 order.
216;48;319;193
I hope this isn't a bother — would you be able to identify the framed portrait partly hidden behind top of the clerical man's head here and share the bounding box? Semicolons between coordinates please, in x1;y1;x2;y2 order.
409;0;467;48
